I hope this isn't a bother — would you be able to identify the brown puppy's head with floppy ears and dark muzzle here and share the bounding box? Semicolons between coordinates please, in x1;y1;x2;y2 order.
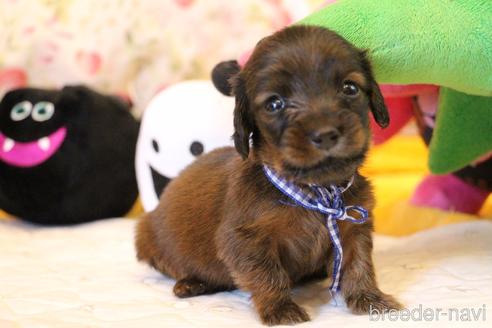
232;26;389;183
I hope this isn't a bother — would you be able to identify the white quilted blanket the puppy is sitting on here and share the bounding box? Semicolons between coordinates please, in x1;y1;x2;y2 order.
0;219;492;328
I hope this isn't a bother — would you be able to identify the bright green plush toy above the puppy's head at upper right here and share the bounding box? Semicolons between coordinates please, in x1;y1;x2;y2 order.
299;0;492;174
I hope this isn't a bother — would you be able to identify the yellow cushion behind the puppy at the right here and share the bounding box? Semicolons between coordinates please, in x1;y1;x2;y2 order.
362;136;492;236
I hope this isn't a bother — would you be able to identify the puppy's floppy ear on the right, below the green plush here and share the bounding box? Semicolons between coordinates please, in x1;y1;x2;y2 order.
360;51;390;128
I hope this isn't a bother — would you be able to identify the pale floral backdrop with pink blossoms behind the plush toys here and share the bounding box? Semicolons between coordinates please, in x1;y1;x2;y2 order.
0;0;323;114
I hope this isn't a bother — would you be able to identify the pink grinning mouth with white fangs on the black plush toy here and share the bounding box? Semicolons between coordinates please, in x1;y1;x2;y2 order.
0;127;67;167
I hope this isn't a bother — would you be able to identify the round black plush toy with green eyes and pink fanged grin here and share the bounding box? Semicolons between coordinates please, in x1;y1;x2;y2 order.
0;86;139;225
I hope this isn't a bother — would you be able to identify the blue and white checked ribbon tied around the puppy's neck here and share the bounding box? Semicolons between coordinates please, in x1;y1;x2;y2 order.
263;165;369;293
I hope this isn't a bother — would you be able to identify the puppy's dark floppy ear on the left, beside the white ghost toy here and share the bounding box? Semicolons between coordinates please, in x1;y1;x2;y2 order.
230;73;254;159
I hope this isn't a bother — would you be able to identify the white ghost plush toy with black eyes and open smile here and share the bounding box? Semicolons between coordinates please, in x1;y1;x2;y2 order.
136;81;234;211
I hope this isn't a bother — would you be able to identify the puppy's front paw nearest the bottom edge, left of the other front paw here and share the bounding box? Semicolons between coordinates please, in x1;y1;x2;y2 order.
260;300;311;326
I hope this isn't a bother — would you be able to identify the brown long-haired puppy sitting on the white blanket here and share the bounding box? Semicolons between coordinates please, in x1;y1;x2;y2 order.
136;26;400;325
